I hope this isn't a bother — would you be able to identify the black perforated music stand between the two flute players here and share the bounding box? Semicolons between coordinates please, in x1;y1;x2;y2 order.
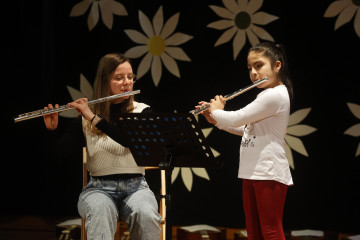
114;113;220;240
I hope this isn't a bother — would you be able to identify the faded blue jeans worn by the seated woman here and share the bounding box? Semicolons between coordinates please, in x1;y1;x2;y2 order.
78;176;161;240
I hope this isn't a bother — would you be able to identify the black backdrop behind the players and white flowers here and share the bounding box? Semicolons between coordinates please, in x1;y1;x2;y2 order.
1;0;360;232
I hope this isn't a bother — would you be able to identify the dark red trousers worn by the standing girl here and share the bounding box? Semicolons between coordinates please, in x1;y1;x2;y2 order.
243;179;288;240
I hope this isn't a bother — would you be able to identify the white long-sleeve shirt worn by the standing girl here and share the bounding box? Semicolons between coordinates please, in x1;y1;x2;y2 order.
212;85;293;185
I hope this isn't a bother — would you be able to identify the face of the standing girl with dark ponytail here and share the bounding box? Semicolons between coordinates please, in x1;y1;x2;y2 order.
248;51;282;88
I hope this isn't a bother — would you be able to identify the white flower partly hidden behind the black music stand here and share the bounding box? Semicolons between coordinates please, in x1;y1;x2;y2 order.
171;116;220;192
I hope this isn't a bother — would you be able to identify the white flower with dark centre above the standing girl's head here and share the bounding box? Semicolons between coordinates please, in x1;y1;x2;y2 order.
207;0;278;60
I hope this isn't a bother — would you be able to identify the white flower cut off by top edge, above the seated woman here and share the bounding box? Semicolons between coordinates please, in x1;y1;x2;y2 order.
70;0;127;31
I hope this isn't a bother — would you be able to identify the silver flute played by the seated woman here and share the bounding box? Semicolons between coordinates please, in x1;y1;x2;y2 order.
14;90;140;123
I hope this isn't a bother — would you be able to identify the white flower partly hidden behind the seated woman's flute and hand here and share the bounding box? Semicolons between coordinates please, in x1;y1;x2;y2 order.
59;74;93;118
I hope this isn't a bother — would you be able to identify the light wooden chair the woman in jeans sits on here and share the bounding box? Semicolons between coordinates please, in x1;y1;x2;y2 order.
81;147;166;240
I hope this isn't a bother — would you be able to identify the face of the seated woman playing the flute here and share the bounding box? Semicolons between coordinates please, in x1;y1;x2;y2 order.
110;62;135;103
